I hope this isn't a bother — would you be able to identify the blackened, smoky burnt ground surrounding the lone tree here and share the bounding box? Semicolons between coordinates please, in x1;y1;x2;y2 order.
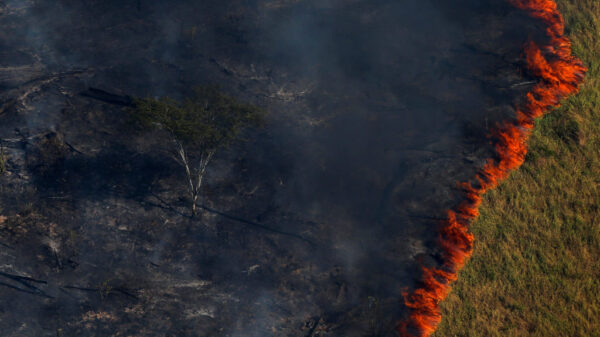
0;0;543;337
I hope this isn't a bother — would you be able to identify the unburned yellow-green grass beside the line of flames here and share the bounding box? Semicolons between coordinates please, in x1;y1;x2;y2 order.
435;0;600;337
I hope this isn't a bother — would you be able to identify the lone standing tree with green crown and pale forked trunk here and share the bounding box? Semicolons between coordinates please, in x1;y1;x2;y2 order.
131;86;264;216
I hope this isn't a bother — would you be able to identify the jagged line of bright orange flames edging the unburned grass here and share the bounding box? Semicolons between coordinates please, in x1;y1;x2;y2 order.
398;0;586;337
